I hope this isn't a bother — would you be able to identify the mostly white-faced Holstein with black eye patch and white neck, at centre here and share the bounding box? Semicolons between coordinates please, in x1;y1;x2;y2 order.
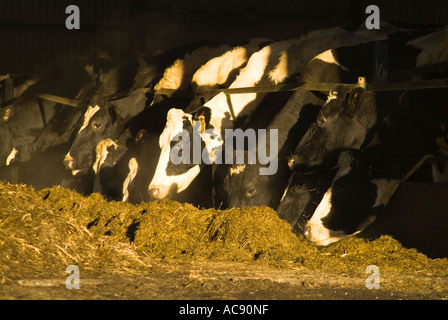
149;39;308;198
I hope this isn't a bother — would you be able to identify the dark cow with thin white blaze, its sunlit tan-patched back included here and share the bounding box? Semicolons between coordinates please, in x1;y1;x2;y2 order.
64;45;233;175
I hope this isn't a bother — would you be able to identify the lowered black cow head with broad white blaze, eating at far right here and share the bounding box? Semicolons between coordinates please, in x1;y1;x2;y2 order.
304;152;382;246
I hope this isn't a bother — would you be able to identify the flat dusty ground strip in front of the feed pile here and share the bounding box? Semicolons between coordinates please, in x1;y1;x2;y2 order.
0;263;448;300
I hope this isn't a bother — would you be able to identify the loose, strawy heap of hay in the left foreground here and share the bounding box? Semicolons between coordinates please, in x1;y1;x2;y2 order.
0;183;148;283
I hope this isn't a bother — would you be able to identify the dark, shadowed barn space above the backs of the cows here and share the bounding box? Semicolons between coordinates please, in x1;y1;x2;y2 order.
0;0;448;74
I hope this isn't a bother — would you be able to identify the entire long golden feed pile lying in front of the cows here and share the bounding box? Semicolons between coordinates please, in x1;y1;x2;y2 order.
0;183;448;288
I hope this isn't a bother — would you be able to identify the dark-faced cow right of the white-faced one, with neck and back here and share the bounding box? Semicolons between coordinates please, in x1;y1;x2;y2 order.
214;28;392;208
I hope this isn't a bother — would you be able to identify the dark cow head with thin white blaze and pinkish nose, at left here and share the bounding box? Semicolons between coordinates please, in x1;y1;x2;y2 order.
64;93;146;175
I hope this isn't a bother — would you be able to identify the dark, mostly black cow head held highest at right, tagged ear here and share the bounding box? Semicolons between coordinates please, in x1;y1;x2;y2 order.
288;86;377;171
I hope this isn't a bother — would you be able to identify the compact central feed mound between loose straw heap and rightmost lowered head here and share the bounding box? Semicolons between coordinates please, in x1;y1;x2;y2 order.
39;187;316;262
